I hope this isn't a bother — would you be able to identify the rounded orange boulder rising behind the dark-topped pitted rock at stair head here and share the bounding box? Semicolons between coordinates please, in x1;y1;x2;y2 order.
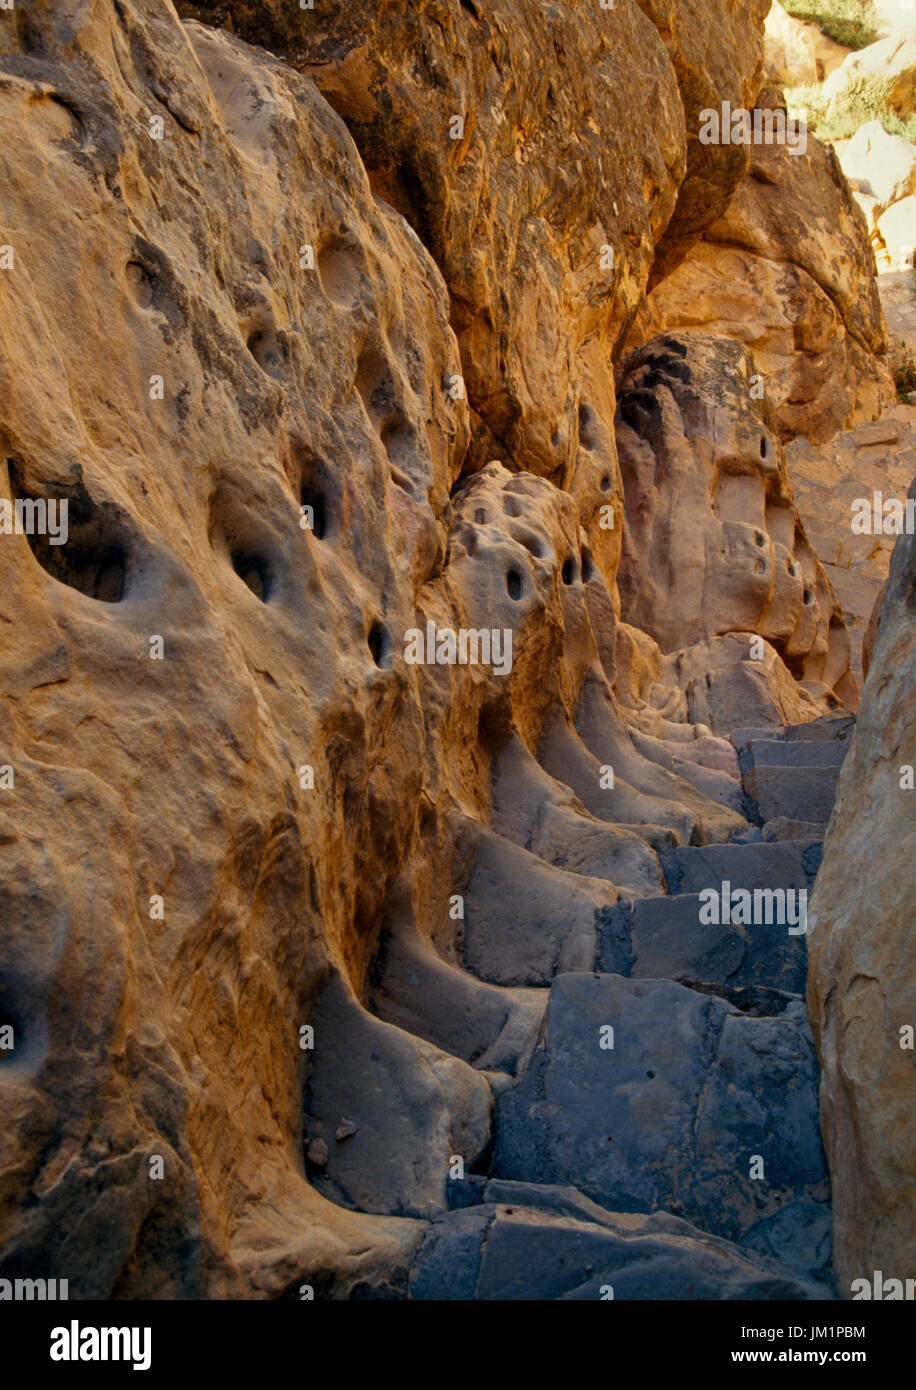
644;93;895;442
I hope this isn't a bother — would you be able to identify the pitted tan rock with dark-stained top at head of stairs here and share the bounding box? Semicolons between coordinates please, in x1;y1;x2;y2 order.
617;334;852;711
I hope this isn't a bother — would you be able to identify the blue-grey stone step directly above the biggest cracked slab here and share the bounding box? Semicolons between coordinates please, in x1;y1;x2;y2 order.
611;880;808;995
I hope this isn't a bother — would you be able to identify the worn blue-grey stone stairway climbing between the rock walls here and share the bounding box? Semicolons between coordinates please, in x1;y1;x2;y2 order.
304;716;852;1300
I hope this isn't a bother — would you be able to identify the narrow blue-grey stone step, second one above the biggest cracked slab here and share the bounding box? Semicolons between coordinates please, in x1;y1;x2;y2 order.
663;838;820;894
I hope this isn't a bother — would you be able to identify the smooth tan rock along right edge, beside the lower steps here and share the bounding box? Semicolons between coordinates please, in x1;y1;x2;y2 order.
808;493;916;1298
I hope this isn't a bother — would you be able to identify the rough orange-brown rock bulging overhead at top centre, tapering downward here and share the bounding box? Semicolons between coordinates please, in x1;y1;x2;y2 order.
181;0;692;500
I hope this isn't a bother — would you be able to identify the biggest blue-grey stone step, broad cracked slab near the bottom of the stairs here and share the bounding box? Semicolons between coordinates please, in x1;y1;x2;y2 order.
491;974;830;1283
